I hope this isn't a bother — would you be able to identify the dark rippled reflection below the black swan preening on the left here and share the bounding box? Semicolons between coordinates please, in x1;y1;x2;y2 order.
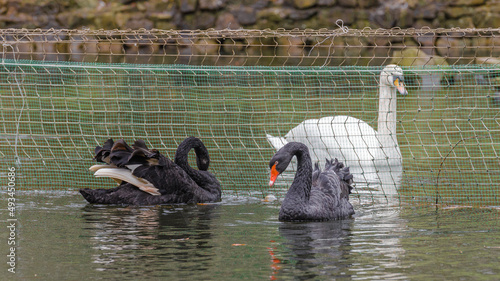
83;205;218;274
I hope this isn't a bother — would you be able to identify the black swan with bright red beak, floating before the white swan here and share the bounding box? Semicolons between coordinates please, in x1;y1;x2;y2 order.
269;142;354;221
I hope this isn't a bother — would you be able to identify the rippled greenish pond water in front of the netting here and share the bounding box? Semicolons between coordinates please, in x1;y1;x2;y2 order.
0;191;500;280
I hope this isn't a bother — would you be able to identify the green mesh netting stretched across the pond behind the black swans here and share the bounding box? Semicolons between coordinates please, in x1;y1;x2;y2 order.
0;60;500;205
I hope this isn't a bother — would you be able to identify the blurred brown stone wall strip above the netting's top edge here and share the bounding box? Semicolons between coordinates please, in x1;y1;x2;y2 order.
0;0;500;29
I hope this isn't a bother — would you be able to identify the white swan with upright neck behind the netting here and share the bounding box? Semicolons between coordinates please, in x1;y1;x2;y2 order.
266;64;408;194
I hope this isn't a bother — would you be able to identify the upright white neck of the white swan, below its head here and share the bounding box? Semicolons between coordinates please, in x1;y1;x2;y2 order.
377;78;397;143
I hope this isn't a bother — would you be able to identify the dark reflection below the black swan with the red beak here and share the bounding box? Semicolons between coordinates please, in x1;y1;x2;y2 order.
279;220;353;280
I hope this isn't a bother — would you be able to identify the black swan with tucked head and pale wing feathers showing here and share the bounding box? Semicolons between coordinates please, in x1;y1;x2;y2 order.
80;137;221;205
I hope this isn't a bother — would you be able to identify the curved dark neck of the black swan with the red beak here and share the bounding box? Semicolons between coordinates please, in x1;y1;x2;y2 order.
283;143;312;201
